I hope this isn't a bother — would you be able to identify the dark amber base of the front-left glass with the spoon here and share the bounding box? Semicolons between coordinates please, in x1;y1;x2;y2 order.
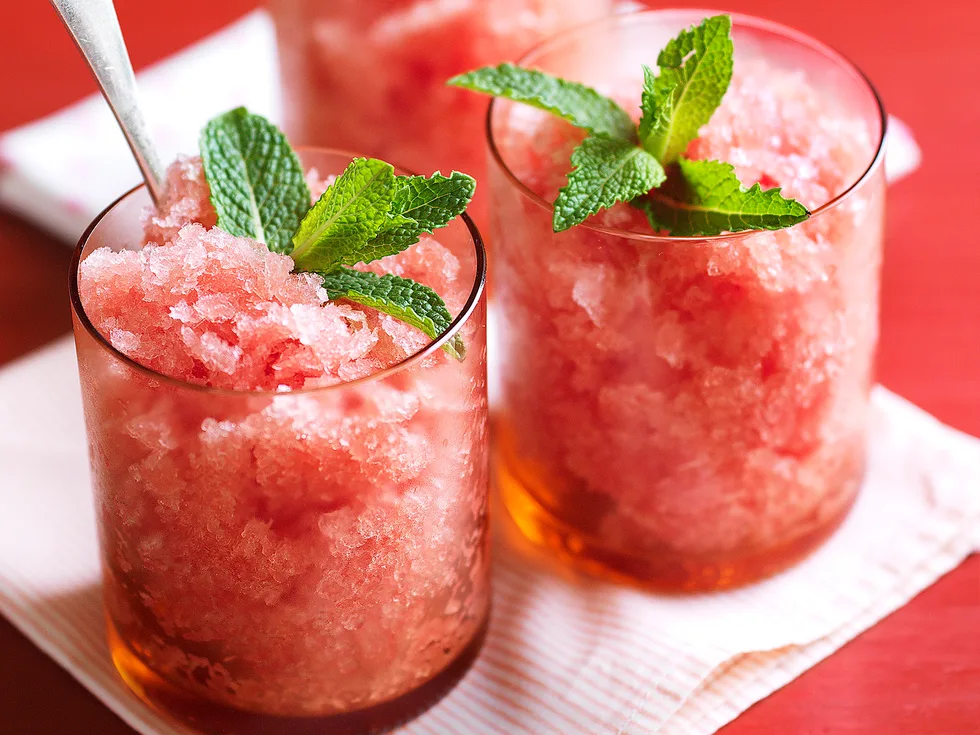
108;613;489;735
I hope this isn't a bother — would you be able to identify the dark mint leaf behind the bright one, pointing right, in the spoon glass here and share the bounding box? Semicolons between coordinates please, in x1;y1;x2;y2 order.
370;171;476;257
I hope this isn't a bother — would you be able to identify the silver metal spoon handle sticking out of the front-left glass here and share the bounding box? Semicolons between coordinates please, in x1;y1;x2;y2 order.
51;0;163;202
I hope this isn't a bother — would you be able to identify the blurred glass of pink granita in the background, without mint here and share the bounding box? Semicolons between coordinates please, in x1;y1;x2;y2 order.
270;0;612;229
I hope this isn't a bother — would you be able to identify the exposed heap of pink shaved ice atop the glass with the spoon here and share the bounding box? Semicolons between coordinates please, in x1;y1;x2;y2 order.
79;158;469;390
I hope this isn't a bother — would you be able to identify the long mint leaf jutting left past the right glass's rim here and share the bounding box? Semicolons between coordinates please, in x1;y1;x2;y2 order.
447;64;636;141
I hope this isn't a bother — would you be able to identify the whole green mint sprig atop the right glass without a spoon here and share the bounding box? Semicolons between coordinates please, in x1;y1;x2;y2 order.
448;15;810;237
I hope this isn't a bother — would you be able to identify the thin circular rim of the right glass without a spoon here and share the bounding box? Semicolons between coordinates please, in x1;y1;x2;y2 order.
485;8;888;243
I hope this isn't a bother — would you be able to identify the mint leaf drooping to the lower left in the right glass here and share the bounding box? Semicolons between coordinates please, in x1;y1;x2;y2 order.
552;137;664;232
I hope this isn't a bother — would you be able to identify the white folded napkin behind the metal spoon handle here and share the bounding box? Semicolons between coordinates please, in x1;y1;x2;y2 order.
0;11;281;243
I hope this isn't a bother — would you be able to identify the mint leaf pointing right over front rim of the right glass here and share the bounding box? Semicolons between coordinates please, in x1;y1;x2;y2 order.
633;158;810;237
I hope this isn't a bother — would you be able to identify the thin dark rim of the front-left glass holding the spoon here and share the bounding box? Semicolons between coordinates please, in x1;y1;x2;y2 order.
68;146;487;397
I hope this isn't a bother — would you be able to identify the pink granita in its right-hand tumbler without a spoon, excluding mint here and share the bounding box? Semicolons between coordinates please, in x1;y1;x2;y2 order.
490;11;884;590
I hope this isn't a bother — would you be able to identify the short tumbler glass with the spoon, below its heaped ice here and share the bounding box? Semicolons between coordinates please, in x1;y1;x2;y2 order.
71;150;490;735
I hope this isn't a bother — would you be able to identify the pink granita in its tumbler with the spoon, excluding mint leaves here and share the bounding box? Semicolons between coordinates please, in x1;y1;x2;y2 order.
73;151;489;733
